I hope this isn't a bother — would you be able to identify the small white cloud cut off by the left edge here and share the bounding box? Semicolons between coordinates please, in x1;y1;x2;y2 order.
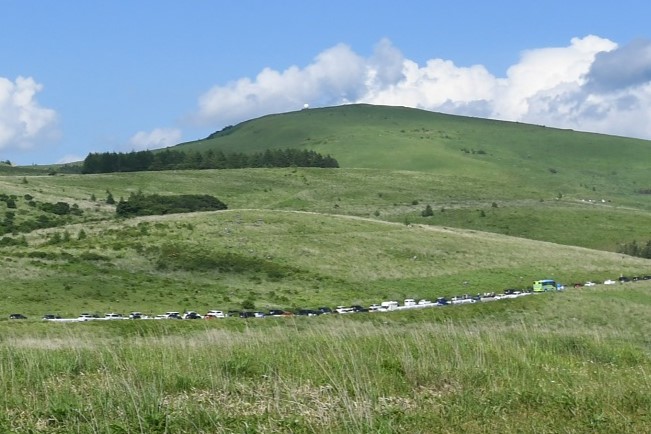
0;77;57;150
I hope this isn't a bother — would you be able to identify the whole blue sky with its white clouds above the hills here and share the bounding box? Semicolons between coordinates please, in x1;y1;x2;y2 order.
0;0;651;164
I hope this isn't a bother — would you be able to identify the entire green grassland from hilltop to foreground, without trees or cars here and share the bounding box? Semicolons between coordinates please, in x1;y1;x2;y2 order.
0;105;651;433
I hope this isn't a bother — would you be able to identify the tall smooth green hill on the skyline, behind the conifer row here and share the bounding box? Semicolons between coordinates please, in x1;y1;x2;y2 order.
173;104;651;207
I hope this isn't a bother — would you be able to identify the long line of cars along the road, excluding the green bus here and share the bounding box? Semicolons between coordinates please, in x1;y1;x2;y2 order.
9;275;651;322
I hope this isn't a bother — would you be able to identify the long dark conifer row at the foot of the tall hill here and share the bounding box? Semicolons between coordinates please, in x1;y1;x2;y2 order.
81;149;339;173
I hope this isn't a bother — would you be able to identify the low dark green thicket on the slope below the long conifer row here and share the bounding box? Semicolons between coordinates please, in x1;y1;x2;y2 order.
115;192;227;217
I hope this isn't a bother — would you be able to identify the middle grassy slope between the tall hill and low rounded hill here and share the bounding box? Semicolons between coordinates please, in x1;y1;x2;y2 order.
5;168;651;251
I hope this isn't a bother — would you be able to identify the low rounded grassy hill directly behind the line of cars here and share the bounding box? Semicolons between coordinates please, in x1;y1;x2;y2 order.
5;210;651;315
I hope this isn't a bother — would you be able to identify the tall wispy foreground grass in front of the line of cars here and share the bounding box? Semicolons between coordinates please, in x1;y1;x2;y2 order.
0;289;651;433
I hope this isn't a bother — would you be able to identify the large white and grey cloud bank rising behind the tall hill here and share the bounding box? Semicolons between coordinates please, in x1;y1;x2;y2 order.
195;35;651;139
